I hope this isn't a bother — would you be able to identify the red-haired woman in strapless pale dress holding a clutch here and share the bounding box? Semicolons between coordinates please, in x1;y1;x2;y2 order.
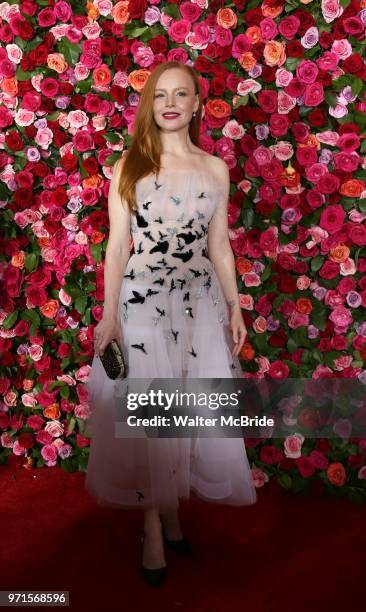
86;61;256;586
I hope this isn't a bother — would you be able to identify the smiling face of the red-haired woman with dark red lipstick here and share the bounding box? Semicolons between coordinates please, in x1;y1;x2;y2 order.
153;68;199;130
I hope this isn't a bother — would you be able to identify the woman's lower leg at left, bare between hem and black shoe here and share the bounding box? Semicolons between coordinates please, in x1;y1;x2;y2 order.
142;508;166;569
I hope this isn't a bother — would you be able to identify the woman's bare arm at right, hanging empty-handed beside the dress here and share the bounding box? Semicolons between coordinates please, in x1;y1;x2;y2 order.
207;158;247;356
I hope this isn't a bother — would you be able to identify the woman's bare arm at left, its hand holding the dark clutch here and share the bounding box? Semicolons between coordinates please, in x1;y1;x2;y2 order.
94;156;130;354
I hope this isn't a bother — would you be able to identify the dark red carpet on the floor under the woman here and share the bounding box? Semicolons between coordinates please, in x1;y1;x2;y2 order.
0;466;366;612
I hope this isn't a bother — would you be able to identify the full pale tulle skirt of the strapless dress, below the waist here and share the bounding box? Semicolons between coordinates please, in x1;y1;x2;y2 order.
85;272;257;511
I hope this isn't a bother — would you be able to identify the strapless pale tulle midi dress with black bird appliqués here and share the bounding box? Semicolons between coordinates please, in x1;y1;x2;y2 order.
85;169;257;511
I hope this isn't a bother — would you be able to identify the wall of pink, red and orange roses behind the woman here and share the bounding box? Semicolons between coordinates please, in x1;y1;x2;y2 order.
0;0;366;502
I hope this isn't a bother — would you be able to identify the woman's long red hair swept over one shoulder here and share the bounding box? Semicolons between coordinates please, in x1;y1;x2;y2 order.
118;61;202;213
